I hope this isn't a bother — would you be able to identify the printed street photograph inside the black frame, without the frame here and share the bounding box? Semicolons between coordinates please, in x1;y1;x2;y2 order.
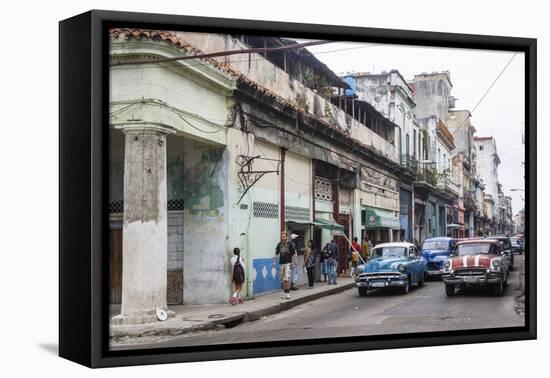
108;28;529;350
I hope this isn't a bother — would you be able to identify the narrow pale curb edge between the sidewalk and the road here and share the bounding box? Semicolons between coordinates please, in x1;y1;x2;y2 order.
109;282;355;343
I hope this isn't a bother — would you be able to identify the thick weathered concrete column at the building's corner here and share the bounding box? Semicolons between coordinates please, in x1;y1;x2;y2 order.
113;124;173;324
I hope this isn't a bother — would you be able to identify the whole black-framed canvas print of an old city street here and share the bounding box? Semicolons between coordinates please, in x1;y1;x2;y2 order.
59;10;537;367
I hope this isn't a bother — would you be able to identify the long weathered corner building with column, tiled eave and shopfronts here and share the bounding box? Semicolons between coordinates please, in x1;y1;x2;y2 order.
109;29;406;323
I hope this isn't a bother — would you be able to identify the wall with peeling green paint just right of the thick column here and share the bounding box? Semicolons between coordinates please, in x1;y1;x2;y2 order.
182;138;229;304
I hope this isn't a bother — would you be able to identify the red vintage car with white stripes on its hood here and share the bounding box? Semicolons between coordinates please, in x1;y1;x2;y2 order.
442;239;508;296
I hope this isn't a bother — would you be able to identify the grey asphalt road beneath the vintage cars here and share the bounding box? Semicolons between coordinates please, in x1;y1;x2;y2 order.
115;256;524;349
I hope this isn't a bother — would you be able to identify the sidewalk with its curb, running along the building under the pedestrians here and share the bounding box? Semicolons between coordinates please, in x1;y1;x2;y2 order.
109;277;355;343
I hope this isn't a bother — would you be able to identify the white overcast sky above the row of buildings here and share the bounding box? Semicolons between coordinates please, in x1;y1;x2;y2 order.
308;42;525;214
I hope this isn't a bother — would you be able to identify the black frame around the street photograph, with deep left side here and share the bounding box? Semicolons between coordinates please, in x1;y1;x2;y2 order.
59;10;537;368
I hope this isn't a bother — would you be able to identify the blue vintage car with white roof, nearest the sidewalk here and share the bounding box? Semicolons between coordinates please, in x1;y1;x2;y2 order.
355;242;427;297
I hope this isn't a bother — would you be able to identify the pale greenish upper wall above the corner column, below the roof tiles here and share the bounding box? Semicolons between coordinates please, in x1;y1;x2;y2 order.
110;39;235;144
